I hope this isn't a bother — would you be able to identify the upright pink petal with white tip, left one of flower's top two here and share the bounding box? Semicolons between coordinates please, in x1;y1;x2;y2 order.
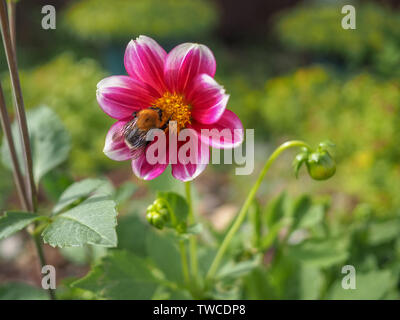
124;36;167;96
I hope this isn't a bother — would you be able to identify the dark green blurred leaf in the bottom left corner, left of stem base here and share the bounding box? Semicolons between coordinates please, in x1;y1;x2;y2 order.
0;282;48;300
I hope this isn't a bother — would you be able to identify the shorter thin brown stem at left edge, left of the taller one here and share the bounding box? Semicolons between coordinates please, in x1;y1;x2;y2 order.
0;83;28;210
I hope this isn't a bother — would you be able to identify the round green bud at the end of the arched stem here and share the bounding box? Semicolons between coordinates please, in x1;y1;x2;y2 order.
306;150;336;180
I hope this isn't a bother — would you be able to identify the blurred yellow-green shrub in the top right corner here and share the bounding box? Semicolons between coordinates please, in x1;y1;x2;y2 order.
276;1;400;75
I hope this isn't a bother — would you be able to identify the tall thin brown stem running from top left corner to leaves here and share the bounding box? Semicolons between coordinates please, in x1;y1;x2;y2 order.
0;0;37;212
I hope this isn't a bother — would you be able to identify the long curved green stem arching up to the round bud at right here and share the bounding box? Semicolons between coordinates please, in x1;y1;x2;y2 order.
206;140;311;283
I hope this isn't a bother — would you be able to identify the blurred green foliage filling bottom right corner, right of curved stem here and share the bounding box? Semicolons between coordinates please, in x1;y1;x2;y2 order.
231;193;400;299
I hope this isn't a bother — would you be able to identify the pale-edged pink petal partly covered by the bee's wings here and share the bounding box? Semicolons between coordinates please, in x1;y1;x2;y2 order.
103;120;132;161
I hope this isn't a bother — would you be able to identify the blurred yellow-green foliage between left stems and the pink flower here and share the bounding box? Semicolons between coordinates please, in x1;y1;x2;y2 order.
4;53;113;176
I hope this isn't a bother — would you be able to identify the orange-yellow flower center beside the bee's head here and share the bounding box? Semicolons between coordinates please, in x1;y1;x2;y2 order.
153;92;192;131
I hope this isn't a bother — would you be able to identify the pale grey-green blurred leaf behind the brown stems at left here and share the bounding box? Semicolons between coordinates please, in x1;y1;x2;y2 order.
1;106;70;184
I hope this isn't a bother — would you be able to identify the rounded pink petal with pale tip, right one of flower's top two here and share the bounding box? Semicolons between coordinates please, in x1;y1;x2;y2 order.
164;43;217;93
